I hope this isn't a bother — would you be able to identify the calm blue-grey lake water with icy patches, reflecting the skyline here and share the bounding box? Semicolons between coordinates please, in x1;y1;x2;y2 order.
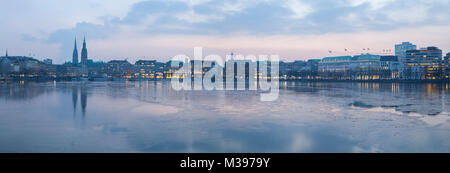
0;81;450;153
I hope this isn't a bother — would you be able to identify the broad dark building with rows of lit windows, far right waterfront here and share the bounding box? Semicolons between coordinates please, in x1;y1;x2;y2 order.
403;47;444;80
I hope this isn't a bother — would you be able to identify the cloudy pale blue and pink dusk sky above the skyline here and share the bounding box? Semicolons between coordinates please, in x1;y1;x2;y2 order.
0;0;450;63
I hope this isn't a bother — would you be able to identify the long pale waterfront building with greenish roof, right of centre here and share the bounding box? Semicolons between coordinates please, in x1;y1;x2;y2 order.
318;56;352;80
